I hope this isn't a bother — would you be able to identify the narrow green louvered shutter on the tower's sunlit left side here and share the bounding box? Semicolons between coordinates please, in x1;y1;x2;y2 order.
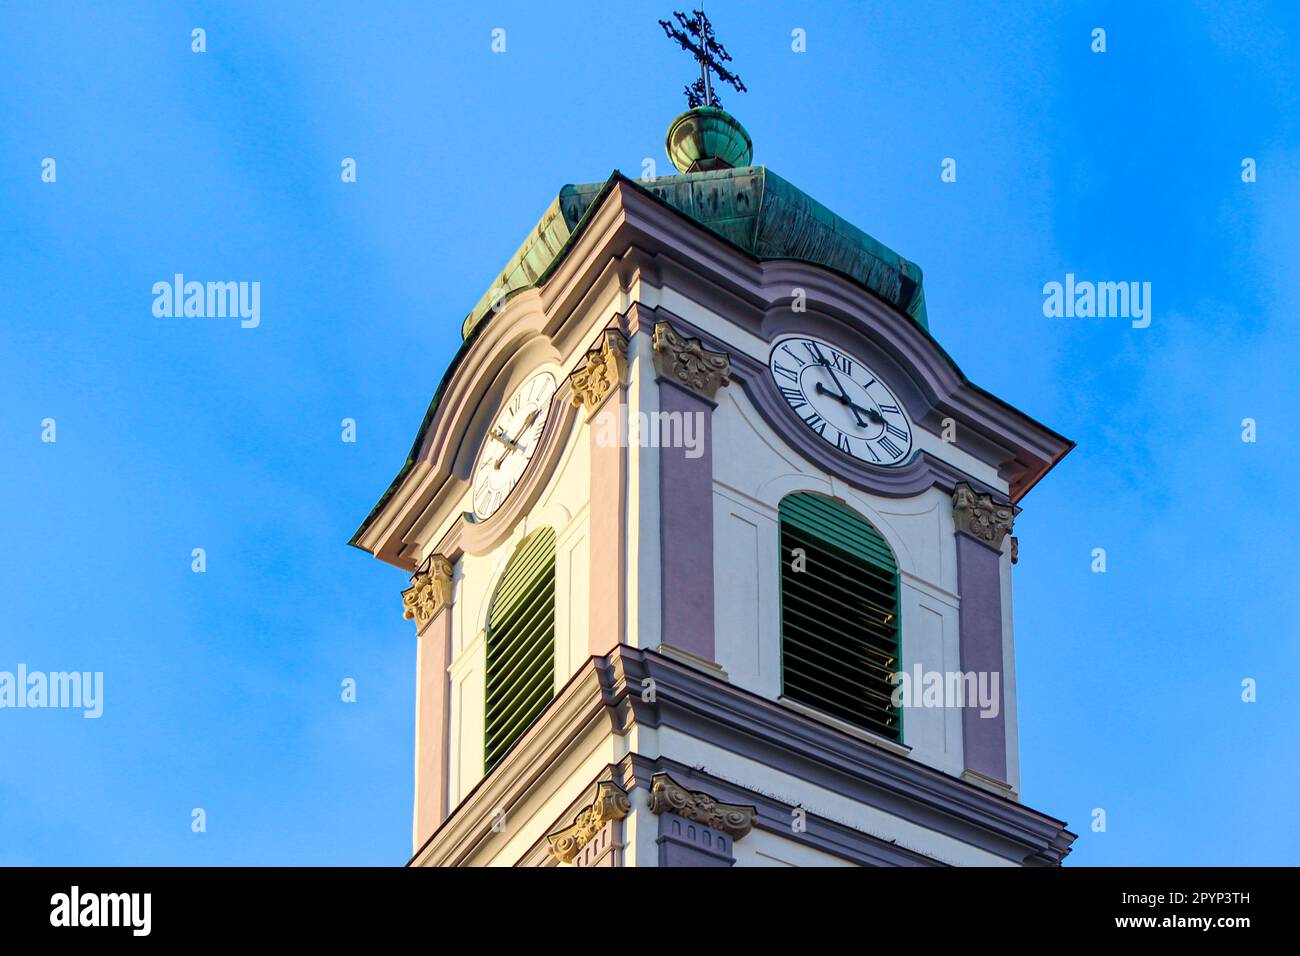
484;528;555;770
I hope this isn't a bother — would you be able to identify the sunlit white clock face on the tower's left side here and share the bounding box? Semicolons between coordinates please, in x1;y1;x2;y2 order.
473;372;555;519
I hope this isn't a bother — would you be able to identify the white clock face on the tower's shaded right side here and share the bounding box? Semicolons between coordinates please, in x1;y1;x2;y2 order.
768;336;911;467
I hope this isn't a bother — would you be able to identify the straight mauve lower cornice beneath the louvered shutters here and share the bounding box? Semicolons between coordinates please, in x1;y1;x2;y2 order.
411;645;1075;866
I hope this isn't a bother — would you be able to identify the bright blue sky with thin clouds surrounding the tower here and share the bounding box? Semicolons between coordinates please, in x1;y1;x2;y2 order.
0;0;1300;865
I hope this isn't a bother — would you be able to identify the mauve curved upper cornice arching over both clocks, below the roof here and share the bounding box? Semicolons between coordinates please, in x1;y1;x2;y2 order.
354;181;1073;568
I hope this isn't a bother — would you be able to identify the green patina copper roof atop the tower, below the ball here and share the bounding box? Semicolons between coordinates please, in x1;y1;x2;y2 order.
462;166;930;337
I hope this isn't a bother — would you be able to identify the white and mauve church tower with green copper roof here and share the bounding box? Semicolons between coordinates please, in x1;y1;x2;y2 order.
352;97;1074;866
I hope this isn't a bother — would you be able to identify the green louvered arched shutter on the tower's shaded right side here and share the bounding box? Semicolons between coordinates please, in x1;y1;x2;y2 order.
780;492;902;740
